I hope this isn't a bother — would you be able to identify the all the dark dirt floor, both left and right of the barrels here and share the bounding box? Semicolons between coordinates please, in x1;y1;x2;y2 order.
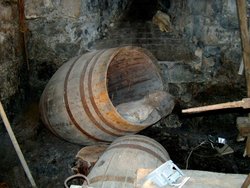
0;102;250;188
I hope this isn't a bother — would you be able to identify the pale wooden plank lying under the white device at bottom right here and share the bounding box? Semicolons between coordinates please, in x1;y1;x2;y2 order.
135;169;247;188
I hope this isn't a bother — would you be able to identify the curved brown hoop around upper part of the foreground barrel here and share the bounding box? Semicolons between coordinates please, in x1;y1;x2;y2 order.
106;144;166;163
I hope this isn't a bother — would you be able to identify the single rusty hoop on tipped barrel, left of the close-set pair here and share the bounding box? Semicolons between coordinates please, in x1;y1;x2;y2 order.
64;56;105;142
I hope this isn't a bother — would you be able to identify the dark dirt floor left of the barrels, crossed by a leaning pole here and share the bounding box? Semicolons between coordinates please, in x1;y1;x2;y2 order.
0;103;82;188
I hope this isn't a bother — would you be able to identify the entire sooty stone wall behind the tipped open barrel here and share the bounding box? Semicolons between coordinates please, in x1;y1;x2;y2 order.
0;0;245;113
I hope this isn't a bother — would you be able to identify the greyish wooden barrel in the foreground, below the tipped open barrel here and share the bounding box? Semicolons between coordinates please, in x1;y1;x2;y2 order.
88;135;170;188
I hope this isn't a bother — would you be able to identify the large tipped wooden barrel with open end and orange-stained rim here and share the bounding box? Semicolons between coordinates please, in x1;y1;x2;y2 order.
40;47;163;145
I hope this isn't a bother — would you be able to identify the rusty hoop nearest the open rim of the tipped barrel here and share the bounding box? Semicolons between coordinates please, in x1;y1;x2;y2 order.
88;49;135;133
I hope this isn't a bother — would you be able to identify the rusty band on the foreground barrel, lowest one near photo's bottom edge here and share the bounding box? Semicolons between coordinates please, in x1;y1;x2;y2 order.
89;175;135;184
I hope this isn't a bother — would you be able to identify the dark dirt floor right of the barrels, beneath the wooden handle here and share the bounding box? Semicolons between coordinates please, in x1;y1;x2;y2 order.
142;110;250;174
